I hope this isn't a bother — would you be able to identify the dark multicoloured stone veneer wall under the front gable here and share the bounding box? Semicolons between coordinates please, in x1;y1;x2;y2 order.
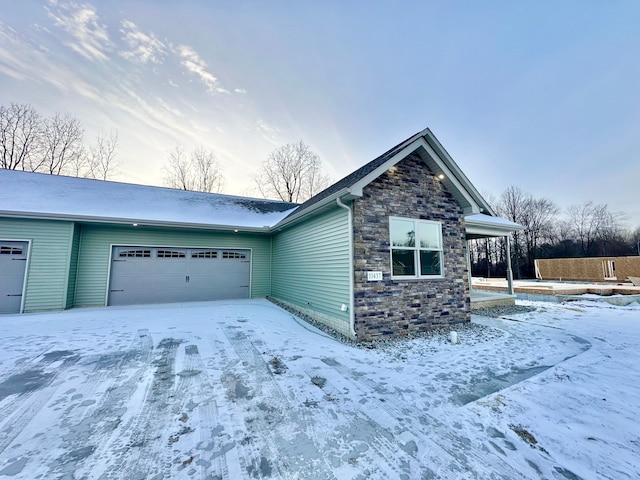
353;157;470;341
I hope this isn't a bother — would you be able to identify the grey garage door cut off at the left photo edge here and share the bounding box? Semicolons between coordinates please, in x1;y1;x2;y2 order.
0;240;27;313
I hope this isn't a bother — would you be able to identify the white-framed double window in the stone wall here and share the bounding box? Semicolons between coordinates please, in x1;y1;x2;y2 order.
389;217;443;278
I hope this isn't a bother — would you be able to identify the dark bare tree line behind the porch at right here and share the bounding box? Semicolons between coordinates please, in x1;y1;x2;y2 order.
470;186;640;278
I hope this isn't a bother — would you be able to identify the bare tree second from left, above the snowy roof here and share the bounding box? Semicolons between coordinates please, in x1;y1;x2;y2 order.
35;113;84;175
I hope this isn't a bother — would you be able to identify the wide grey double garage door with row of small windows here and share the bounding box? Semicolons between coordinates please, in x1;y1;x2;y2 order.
108;247;251;305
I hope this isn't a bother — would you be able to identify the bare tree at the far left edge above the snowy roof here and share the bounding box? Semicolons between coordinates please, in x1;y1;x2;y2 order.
0;103;42;170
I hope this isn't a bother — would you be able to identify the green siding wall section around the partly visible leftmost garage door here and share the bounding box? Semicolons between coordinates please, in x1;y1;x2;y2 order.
0;218;73;312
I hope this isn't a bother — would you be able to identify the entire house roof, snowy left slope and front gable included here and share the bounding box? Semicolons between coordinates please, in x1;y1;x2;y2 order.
0;128;522;236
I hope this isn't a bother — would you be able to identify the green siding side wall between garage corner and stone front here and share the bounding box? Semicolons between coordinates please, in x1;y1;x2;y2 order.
271;207;350;330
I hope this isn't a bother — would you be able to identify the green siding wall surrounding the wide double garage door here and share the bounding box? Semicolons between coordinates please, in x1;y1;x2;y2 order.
75;224;271;306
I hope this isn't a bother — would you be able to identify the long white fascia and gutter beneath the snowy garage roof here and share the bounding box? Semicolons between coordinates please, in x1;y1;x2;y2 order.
0;211;271;233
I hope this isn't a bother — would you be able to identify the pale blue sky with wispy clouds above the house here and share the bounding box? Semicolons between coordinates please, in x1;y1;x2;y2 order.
0;0;640;228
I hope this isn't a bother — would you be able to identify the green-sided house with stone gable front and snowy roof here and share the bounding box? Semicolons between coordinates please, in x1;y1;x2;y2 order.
0;129;521;341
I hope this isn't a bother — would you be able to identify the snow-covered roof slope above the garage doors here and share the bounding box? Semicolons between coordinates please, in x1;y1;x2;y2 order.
0;170;297;229
